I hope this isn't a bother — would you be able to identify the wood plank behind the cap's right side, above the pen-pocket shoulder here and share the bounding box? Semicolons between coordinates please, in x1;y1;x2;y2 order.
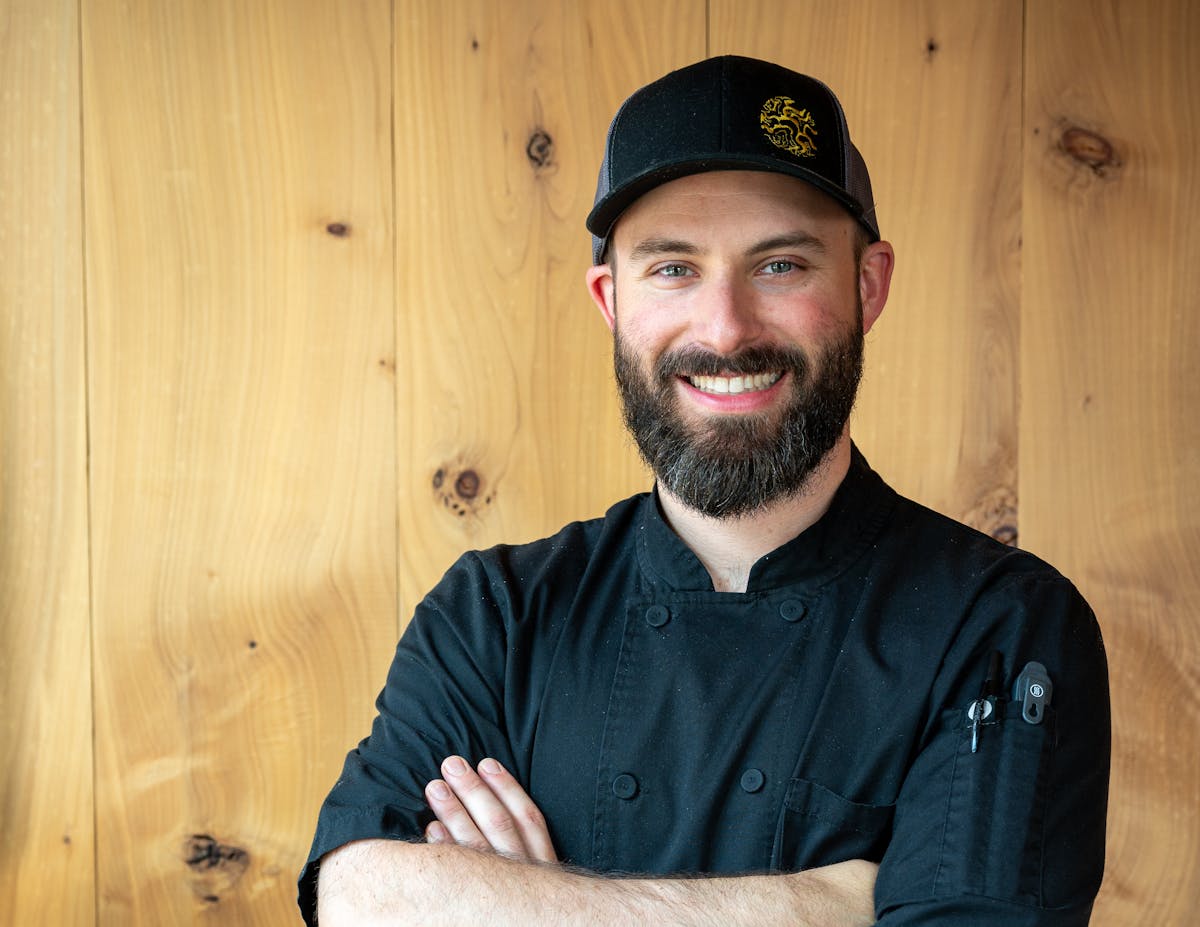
710;0;1021;542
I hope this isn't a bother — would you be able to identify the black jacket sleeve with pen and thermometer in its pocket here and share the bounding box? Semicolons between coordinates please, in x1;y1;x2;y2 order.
876;574;1110;927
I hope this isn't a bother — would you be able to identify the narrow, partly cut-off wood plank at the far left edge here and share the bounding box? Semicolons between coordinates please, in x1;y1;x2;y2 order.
0;0;95;925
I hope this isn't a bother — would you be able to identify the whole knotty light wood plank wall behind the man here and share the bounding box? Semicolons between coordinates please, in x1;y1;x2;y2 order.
0;0;1200;927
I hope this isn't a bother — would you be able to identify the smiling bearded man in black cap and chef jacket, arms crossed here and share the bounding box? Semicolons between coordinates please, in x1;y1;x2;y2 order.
300;58;1109;927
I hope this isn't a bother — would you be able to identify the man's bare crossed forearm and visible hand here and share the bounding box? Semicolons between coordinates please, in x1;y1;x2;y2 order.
317;756;877;927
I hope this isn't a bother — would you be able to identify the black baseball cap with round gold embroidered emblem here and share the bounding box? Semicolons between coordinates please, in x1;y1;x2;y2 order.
587;55;880;264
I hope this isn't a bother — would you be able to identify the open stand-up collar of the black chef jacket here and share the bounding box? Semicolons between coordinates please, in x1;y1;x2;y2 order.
637;445;895;592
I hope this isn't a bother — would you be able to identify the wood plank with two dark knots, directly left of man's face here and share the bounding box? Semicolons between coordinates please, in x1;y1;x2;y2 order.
396;0;704;616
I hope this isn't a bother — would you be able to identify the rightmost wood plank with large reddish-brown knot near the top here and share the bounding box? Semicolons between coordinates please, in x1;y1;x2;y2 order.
1020;0;1200;927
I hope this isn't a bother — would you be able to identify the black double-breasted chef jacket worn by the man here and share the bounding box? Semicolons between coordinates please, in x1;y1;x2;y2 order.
300;450;1109;927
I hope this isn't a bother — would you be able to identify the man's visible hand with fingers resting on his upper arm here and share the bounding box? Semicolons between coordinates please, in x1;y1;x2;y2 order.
425;756;558;862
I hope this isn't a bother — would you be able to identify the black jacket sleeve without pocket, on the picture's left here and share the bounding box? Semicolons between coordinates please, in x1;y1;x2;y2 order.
298;554;512;925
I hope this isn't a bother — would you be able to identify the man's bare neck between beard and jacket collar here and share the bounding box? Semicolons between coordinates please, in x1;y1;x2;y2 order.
659;433;850;592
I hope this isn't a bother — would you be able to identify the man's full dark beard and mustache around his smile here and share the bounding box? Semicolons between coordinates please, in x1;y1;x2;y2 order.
613;324;863;518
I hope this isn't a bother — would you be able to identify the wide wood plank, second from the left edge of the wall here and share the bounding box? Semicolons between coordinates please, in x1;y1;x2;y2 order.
82;0;396;925
